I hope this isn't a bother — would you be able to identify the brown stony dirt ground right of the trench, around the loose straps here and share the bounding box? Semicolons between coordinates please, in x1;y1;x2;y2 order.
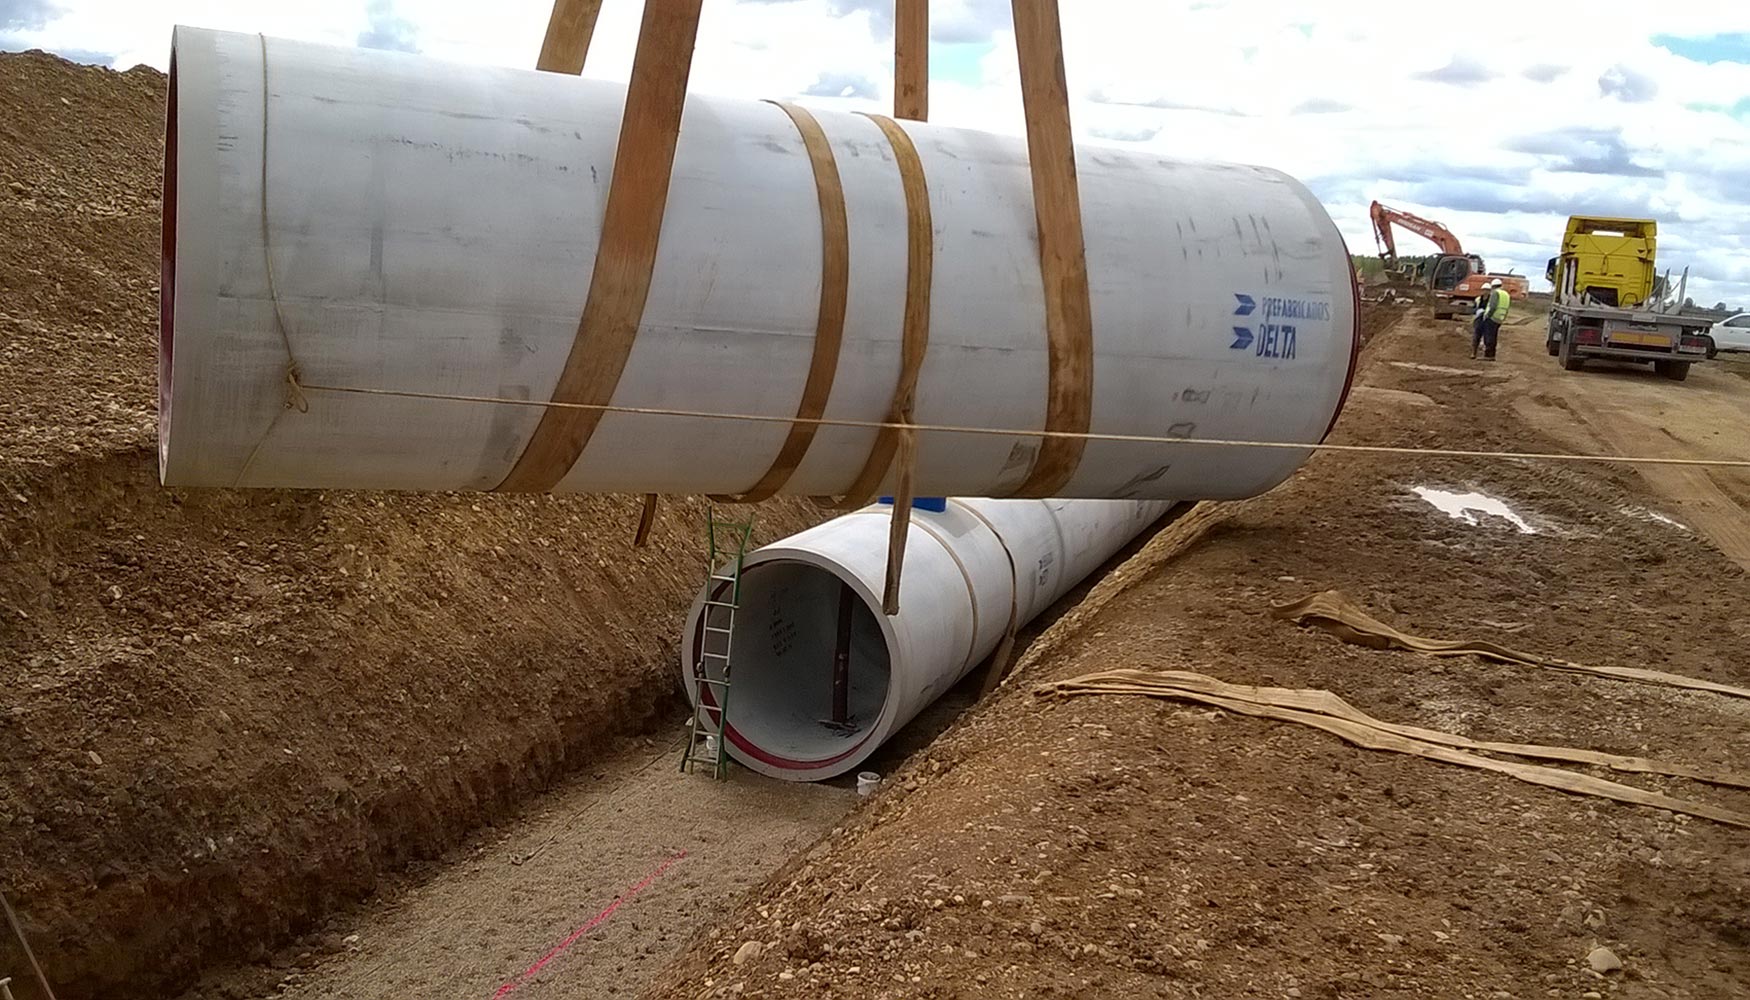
646;317;1750;1000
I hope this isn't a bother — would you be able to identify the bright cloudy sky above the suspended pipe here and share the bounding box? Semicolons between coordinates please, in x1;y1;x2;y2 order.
10;0;1750;308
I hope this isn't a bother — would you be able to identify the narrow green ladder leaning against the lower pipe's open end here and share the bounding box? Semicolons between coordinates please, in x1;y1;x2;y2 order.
681;506;754;781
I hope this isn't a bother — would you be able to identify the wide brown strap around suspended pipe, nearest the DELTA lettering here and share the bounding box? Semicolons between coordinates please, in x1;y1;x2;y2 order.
1012;0;1094;497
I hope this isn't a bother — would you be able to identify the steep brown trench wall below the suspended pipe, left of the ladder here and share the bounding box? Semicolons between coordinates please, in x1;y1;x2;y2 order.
0;448;833;1000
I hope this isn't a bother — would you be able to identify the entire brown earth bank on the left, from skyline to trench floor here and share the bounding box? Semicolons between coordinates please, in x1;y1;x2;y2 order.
0;53;817;998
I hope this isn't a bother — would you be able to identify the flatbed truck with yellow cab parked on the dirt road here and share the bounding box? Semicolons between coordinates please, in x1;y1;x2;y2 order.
1545;215;1713;382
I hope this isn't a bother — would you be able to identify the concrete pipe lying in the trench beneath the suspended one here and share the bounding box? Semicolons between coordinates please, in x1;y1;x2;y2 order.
681;499;1173;781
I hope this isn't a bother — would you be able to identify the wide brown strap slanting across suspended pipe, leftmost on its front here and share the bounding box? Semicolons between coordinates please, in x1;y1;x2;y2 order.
499;0;704;492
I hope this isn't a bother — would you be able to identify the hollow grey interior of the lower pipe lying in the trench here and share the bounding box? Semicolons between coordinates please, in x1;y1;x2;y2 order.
695;560;891;767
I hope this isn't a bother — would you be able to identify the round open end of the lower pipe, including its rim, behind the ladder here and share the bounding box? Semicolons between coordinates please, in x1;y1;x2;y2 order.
690;559;893;781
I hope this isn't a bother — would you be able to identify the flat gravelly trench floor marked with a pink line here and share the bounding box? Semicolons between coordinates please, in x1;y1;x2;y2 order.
181;730;856;1000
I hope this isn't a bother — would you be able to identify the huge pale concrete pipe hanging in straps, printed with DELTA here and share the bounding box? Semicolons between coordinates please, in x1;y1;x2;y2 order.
159;28;1356;499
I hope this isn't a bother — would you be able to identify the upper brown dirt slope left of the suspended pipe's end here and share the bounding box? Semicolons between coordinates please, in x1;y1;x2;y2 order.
0;53;165;466
